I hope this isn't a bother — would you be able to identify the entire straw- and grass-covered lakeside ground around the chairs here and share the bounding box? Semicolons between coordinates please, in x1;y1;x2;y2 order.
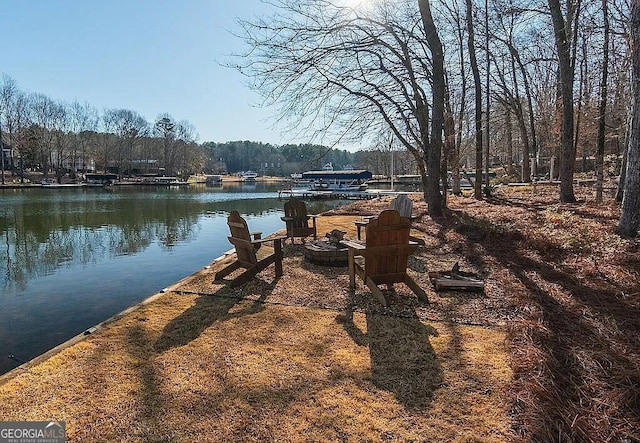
0;188;640;442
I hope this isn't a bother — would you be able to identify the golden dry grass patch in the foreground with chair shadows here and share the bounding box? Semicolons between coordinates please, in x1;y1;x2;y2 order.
0;283;511;442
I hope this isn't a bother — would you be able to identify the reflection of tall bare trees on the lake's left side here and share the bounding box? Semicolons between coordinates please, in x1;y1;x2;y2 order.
0;196;204;287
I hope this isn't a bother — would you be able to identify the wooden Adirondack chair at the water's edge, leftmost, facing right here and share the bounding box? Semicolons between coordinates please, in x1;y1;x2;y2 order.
215;211;286;288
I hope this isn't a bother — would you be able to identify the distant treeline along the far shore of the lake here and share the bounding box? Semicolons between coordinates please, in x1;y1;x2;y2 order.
0;73;415;183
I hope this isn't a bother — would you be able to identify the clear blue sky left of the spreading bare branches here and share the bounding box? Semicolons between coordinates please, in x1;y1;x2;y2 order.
0;0;296;144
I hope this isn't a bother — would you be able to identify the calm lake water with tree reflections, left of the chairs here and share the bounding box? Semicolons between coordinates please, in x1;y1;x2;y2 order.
0;183;344;374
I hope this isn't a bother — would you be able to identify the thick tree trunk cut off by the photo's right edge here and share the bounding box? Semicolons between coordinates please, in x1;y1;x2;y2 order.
618;0;640;237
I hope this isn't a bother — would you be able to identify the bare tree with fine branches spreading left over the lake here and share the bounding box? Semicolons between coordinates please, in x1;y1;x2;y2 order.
236;0;445;215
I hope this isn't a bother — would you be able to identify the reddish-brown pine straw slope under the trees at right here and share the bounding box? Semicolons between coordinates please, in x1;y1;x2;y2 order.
404;188;640;442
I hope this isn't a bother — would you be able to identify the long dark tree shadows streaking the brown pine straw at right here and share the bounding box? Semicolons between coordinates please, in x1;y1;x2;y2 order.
430;200;640;442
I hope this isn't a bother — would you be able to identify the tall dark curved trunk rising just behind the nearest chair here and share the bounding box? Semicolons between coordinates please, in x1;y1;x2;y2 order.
418;0;446;217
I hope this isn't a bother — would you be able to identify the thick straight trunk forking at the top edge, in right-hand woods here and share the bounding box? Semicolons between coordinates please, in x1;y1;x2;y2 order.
548;0;577;203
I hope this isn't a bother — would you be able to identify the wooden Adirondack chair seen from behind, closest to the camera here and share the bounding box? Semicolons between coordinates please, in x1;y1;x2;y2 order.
343;209;429;306
